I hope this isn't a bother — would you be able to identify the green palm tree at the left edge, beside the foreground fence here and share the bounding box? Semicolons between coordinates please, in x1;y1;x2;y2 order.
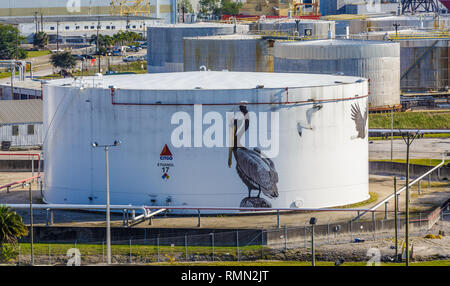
0;205;28;247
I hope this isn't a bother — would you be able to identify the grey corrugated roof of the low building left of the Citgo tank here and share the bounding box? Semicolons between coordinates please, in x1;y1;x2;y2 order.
0;99;42;124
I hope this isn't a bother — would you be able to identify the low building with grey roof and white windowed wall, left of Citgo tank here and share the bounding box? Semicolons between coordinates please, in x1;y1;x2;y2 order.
0;99;43;147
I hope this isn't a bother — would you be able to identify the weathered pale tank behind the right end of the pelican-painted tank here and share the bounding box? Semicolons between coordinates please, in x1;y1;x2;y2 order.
274;40;400;108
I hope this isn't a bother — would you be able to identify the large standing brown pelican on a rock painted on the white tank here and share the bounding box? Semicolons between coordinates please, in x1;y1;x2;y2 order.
228;106;278;208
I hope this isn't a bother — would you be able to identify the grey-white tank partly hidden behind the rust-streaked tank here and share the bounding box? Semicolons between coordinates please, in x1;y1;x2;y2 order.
147;23;248;73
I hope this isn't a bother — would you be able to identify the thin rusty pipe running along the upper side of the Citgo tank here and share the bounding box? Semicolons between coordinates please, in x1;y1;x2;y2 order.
111;88;369;106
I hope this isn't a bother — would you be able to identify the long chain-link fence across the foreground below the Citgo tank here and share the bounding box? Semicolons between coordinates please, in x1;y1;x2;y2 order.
11;202;450;265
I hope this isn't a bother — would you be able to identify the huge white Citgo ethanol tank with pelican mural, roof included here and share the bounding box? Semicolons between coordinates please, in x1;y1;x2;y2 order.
44;71;369;212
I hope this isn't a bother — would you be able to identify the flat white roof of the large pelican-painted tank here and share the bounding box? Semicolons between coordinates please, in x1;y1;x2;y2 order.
46;71;361;90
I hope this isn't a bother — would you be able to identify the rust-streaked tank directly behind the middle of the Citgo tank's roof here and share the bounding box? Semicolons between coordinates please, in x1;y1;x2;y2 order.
184;34;273;72
